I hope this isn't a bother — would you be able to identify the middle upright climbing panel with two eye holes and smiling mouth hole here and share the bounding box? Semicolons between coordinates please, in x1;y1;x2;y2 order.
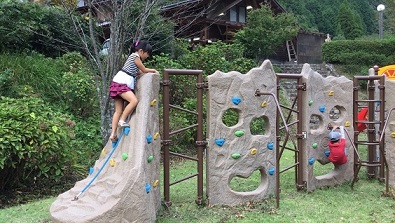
206;60;276;205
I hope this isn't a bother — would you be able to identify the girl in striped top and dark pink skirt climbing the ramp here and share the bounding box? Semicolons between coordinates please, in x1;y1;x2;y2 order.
110;40;158;142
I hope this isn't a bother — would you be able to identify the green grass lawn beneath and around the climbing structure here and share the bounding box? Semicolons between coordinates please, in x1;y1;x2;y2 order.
0;148;395;223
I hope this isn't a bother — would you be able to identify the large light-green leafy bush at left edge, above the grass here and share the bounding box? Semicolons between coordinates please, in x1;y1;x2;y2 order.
0;97;75;190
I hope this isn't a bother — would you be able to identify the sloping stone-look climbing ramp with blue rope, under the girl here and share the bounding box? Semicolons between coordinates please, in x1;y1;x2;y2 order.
50;74;161;223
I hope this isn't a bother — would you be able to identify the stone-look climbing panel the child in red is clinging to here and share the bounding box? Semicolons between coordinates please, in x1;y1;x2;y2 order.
302;64;354;191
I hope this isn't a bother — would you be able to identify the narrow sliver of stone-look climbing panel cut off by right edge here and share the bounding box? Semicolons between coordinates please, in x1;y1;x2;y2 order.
385;78;395;191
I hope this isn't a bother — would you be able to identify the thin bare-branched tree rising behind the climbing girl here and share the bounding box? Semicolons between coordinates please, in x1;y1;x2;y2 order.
54;0;173;142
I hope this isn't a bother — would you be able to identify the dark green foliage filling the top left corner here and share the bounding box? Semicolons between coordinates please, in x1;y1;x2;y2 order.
0;1;87;57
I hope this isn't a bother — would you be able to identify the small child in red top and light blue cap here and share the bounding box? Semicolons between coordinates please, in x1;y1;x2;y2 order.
328;126;347;165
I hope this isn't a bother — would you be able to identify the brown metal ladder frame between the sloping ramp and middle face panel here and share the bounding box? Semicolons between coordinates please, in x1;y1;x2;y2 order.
162;69;207;207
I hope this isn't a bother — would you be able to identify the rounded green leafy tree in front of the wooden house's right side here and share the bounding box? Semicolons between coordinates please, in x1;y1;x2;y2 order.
235;5;299;59
